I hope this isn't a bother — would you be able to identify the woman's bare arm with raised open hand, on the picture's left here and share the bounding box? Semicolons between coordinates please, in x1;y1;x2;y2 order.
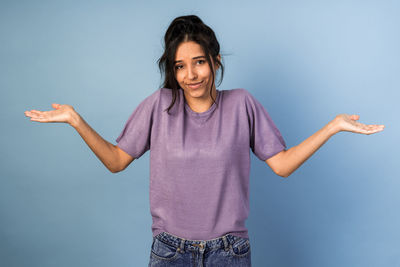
25;104;134;173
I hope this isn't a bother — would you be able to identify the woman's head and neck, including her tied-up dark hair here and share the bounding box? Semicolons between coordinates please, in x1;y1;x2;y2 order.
158;15;224;115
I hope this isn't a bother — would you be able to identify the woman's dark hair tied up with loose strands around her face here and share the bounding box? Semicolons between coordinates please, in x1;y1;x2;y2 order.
157;15;224;113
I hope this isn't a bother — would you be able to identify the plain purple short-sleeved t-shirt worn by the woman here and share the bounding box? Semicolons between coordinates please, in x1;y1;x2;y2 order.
116;88;286;240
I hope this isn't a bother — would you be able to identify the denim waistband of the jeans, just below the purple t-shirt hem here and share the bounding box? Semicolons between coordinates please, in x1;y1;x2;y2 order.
154;232;242;252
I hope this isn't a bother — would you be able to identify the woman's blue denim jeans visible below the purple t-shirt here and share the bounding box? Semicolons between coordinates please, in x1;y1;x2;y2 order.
149;232;251;267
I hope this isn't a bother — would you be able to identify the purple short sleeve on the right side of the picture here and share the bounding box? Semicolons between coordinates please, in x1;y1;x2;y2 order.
246;92;286;161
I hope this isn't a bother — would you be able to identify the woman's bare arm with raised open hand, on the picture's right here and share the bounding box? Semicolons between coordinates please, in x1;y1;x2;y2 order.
265;114;385;177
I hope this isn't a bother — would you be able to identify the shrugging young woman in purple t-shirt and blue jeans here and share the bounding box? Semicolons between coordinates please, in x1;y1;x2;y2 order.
25;16;384;266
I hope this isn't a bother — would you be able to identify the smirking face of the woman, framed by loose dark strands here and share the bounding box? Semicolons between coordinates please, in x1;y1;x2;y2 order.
174;41;220;102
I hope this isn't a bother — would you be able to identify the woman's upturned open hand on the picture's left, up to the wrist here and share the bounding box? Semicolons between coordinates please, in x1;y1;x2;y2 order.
25;104;76;125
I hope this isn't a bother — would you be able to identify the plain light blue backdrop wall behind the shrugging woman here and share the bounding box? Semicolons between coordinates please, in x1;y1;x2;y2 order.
0;0;400;267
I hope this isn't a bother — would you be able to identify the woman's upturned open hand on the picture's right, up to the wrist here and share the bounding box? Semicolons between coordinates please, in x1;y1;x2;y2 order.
333;114;385;134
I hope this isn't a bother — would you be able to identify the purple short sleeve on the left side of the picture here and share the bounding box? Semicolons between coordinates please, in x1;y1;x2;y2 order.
116;90;160;159
